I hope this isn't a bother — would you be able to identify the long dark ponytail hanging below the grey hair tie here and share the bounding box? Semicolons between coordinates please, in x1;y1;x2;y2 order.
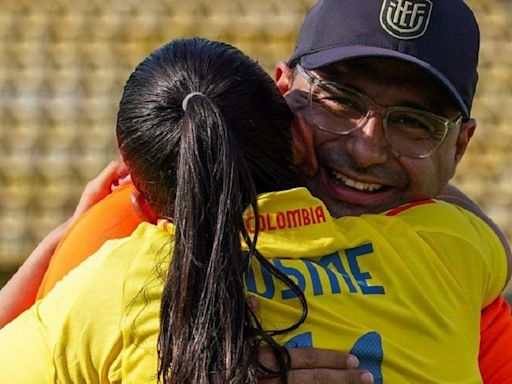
158;95;256;384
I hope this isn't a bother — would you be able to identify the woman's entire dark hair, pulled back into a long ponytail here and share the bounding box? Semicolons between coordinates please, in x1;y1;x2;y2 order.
117;38;306;384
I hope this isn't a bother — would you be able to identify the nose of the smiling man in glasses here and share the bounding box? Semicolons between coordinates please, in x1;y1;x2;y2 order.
346;113;392;168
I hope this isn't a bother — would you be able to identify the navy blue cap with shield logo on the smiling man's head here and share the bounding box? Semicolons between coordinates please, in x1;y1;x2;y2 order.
289;0;480;117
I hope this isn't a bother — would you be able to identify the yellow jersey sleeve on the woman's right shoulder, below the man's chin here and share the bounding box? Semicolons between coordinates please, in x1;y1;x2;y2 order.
396;200;507;309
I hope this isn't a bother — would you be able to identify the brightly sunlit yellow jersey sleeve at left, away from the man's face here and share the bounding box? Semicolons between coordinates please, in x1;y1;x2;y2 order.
0;239;134;384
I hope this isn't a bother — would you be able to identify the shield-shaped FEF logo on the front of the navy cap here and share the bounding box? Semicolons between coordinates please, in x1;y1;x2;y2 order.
380;0;432;40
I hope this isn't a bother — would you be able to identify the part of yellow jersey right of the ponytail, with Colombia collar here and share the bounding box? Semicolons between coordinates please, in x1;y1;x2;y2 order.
246;190;507;384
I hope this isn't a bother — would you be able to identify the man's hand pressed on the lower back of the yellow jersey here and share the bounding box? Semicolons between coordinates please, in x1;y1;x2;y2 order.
258;348;373;384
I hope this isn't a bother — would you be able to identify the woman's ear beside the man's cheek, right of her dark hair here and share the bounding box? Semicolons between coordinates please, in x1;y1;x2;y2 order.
292;115;318;176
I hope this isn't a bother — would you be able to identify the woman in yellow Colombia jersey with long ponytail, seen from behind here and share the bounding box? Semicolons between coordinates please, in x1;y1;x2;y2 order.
0;39;505;383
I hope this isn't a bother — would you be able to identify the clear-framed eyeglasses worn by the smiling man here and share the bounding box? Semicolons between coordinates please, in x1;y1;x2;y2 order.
296;65;462;159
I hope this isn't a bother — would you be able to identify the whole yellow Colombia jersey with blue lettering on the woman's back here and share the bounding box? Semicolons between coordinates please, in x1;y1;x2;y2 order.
0;188;506;384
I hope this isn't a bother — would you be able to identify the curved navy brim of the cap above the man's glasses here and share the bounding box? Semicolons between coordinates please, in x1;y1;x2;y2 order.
300;46;469;117
